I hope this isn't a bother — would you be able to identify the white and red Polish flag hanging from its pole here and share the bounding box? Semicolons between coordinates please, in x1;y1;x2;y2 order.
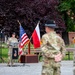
32;23;40;48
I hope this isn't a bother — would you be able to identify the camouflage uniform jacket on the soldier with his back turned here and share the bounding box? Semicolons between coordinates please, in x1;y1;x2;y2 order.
41;31;66;58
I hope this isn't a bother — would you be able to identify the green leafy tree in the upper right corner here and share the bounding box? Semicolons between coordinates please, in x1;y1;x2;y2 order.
59;0;75;31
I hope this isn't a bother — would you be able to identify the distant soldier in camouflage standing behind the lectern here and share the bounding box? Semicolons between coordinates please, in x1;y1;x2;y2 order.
7;33;18;66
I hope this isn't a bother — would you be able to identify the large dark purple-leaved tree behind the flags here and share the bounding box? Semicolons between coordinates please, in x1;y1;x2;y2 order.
0;0;65;36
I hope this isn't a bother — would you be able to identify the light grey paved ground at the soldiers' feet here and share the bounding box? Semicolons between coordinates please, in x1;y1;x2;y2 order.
0;61;73;75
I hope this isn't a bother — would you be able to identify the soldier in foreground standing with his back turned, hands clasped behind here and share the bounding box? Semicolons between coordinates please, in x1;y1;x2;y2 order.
41;20;66;75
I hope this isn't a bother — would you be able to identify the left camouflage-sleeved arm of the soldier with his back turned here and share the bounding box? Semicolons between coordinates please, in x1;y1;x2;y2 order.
41;36;55;58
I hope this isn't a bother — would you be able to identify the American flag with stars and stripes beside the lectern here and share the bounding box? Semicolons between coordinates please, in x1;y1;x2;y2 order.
19;25;29;55
